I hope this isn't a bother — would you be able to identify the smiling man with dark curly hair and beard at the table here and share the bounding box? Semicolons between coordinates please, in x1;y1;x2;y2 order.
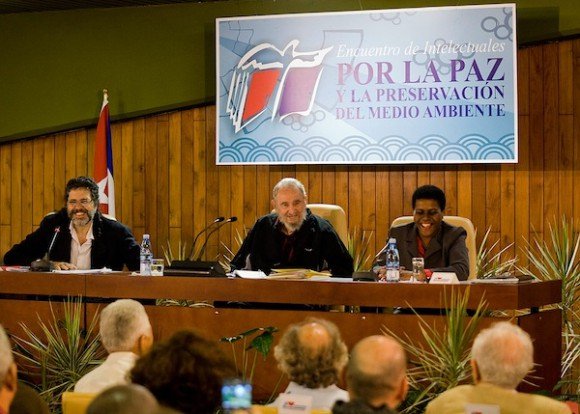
4;177;140;270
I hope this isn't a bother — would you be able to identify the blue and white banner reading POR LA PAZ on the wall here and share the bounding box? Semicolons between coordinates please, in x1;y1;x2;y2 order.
216;4;517;165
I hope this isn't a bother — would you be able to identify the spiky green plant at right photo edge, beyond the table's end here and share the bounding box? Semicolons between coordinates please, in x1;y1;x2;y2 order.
519;217;580;396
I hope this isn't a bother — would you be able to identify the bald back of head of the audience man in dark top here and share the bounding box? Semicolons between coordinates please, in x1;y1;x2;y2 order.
346;335;407;408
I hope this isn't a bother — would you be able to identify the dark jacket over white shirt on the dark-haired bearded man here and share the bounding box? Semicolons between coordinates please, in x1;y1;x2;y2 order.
4;209;140;270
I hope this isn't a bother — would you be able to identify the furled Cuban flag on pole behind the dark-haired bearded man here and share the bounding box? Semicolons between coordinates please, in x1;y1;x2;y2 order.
94;89;115;217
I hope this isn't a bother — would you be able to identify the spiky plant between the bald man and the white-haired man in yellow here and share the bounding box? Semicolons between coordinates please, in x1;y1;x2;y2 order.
382;288;486;413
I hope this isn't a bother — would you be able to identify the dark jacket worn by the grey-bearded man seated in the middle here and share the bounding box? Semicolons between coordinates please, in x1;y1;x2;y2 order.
231;210;353;277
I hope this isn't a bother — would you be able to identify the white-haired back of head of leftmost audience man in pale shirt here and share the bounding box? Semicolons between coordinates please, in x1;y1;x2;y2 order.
100;299;151;353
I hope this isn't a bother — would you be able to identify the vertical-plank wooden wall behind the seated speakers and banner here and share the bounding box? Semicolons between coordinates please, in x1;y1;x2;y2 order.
0;40;580;264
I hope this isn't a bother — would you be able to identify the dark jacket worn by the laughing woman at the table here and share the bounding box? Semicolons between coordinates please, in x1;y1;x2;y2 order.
389;220;469;280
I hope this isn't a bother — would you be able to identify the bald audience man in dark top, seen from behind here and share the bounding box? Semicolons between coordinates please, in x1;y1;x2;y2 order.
332;335;409;414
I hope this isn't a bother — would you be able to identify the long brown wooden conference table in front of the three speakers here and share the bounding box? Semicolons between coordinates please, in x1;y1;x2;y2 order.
0;271;562;398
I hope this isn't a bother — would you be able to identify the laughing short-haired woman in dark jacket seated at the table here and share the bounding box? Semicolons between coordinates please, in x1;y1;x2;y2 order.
374;185;469;280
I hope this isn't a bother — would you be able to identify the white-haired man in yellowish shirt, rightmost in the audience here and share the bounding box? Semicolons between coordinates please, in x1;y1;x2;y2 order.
426;322;570;414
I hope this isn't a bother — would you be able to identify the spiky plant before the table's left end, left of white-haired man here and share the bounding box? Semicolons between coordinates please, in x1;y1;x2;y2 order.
13;297;105;413
